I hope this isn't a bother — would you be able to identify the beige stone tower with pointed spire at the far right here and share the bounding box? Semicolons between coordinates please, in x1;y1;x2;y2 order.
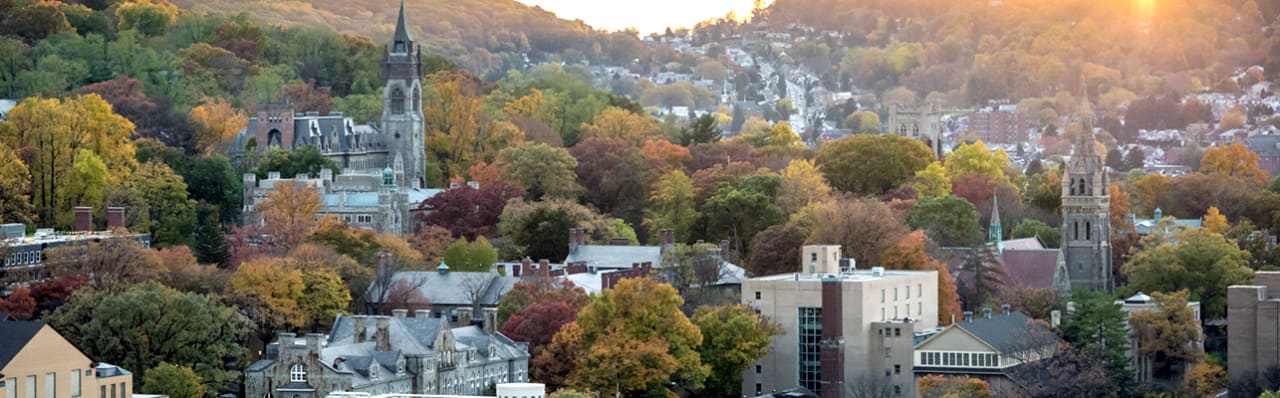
1062;100;1114;291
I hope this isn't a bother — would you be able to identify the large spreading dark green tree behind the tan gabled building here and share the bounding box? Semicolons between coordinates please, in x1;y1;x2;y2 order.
46;283;252;392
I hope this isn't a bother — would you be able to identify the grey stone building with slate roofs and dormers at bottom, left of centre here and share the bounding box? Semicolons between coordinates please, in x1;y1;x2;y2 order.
244;310;529;398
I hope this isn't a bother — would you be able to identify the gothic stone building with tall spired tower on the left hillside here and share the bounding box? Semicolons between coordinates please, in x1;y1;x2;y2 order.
230;4;440;235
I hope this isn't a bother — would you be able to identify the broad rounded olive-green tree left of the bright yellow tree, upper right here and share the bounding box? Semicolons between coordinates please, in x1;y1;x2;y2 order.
814;134;934;195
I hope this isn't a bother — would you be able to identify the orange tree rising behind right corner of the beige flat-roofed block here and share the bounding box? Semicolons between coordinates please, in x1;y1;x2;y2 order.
879;230;964;325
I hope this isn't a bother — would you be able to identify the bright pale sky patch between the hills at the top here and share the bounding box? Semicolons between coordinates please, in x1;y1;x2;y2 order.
516;0;752;35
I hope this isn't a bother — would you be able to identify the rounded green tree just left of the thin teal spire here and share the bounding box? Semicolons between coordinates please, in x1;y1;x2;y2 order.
906;196;983;247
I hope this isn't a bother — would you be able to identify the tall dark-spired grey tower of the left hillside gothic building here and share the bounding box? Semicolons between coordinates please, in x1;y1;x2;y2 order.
381;0;426;188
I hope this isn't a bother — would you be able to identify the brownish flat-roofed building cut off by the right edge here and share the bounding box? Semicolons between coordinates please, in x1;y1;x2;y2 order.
1226;271;1280;383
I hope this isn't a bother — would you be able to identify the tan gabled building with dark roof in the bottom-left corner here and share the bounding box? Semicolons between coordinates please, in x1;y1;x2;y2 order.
0;320;133;398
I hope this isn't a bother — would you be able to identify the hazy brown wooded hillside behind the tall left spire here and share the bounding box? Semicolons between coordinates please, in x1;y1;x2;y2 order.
173;0;639;70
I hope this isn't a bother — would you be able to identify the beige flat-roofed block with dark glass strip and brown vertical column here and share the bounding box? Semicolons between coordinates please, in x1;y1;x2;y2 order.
742;246;938;397
